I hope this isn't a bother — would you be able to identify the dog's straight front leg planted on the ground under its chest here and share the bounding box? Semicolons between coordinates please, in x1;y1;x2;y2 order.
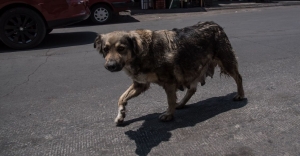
159;84;177;121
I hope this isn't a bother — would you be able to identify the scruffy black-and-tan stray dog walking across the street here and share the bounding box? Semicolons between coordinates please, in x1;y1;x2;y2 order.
94;22;244;125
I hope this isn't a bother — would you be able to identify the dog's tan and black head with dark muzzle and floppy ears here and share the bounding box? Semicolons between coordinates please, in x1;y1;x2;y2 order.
94;31;142;72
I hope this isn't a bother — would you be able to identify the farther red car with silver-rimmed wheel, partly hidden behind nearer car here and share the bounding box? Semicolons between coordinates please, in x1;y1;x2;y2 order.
89;0;133;24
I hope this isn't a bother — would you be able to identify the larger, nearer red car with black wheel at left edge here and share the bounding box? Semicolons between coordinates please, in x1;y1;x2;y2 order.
0;0;90;49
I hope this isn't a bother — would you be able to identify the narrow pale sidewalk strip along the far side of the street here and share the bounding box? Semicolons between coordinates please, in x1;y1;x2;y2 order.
130;1;300;15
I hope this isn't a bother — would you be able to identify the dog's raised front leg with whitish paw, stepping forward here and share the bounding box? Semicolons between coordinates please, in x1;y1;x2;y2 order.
115;81;150;125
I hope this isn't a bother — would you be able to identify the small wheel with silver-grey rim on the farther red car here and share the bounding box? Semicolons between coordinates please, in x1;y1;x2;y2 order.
90;4;112;24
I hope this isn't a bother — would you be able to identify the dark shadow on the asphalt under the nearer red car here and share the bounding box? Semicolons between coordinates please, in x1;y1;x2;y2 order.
0;31;97;53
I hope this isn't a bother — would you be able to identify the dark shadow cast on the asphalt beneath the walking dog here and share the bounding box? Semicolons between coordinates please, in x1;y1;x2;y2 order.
124;93;248;156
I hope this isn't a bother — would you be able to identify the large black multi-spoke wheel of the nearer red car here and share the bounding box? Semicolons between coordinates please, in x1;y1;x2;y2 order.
0;7;46;49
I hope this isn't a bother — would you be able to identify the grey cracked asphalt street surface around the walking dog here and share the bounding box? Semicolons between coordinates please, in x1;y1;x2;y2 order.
0;6;300;156
